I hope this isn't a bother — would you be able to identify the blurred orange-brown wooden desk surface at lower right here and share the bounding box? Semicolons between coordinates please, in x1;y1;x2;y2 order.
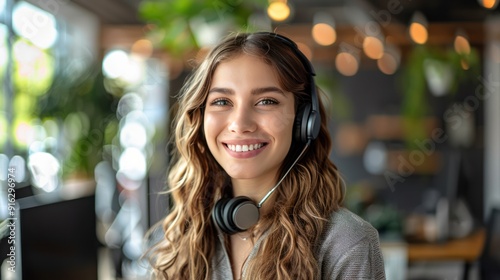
408;229;486;262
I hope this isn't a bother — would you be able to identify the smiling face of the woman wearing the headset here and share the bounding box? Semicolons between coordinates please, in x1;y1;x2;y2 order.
204;54;295;184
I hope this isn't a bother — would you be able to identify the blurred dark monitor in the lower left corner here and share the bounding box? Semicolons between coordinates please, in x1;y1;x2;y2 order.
19;196;99;280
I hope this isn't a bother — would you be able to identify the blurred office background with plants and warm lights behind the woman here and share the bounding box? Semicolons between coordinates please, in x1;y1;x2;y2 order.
0;0;500;279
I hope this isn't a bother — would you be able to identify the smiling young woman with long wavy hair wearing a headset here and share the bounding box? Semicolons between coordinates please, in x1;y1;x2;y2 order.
151;33;385;280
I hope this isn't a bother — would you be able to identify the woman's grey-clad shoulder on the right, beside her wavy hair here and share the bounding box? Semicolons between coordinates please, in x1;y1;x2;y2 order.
316;208;385;279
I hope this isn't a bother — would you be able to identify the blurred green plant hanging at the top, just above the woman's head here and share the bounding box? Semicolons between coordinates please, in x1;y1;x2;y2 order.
139;0;267;57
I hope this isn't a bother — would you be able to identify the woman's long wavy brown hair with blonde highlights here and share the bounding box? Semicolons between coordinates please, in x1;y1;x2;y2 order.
150;33;344;280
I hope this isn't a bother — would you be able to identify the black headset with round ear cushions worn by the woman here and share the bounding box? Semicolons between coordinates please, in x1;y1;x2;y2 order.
212;32;321;234
